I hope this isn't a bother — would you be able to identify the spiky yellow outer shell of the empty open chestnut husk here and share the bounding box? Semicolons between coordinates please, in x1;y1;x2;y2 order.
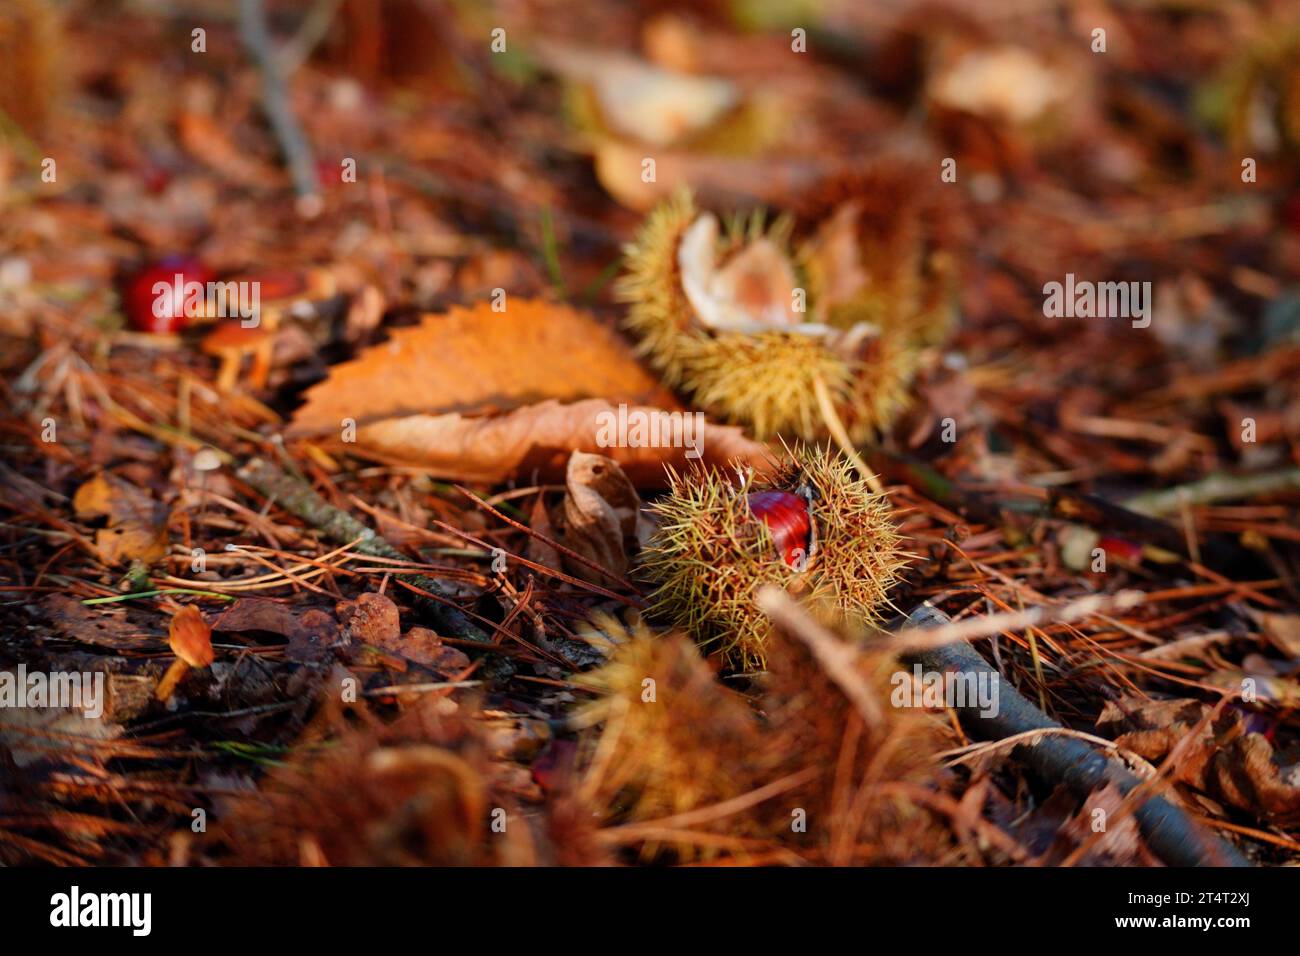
616;193;946;442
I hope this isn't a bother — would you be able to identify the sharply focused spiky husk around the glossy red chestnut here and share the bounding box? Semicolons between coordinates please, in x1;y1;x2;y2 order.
642;447;905;670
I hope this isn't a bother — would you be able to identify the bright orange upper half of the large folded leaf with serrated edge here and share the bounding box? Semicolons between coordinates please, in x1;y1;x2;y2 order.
290;298;677;434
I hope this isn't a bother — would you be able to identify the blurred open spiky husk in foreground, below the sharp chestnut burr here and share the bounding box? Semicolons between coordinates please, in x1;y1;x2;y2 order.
575;619;959;865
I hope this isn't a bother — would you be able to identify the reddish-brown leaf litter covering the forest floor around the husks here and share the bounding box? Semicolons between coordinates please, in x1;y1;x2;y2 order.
0;0;1300;865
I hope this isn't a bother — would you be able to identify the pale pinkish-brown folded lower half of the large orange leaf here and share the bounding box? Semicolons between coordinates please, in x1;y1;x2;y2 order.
342;399;772;488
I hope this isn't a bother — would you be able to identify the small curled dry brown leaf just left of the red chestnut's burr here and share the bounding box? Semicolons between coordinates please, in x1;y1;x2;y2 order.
551;451;653;581
